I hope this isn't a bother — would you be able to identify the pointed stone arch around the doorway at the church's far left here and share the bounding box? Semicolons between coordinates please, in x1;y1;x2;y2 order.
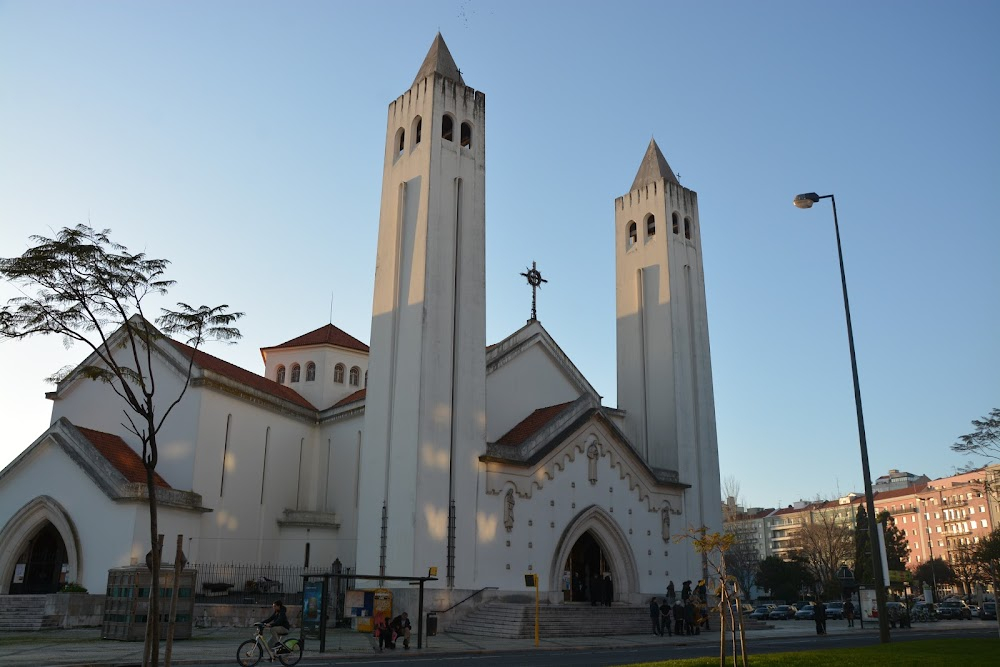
0;496;80;595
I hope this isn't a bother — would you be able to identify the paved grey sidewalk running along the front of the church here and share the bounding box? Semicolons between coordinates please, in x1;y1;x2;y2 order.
0;621;944;667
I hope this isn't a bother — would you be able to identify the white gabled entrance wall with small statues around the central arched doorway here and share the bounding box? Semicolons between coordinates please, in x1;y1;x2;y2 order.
476;422;701;603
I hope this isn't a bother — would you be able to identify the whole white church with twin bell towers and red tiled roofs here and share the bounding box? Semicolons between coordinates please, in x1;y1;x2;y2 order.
0;35;722;603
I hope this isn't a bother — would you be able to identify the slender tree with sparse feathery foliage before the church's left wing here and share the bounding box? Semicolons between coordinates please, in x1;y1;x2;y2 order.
0;225;243;667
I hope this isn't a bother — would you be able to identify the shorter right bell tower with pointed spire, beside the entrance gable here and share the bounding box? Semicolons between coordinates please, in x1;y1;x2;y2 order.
615;140;722;530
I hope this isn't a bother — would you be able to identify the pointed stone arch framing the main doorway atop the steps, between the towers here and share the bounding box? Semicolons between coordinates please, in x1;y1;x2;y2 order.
548;505;639;601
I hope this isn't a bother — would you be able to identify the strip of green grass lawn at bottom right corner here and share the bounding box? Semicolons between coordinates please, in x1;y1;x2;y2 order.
632;639;998;667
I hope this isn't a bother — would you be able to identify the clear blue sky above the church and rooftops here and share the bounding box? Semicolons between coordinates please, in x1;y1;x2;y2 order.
0;1;1000;506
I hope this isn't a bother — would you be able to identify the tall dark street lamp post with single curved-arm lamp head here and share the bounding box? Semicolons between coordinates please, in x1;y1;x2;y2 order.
793;192;889;644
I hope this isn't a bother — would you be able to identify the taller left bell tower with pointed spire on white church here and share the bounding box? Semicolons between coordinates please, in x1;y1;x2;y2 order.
357;34;486;588
